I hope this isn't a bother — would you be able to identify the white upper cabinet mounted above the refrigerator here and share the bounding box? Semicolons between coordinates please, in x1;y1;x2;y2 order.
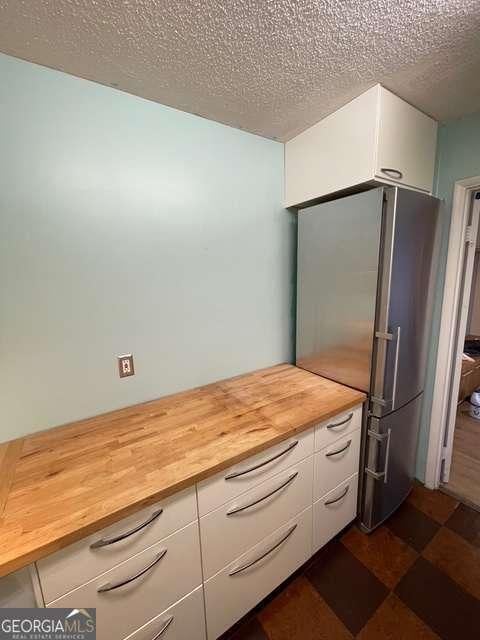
285;85;437;207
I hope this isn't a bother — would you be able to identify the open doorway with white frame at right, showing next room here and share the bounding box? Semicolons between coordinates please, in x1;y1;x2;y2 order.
425;177;480;510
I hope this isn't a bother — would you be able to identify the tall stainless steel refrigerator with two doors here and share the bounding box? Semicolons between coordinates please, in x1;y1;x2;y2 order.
296;187;440;531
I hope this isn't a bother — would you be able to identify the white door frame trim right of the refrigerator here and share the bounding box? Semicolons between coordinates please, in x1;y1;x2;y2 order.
425;176;480;489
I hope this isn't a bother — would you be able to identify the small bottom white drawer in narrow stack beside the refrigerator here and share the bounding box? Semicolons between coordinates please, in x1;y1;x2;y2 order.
313;473;358;553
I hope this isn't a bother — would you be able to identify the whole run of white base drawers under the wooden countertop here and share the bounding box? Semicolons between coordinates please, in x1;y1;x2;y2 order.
32;406;362;640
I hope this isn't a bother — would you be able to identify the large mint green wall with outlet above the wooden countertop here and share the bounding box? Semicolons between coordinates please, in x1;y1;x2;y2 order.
0;55;295;440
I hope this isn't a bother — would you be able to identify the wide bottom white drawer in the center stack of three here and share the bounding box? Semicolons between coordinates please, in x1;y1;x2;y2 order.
205;507;312;640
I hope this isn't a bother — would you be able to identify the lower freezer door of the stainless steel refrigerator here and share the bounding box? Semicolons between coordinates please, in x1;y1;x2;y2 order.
361;394;423;531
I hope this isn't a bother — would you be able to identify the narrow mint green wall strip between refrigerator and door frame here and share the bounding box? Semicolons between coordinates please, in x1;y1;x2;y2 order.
417;113;480;480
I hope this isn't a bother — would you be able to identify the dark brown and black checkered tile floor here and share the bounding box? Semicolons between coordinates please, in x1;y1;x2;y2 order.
225;484;480;640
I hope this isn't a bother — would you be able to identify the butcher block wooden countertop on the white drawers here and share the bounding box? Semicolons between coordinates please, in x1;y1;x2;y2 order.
0;364;365;576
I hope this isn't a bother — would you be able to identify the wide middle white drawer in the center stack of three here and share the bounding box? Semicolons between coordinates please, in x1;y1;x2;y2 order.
200;456;314;578
